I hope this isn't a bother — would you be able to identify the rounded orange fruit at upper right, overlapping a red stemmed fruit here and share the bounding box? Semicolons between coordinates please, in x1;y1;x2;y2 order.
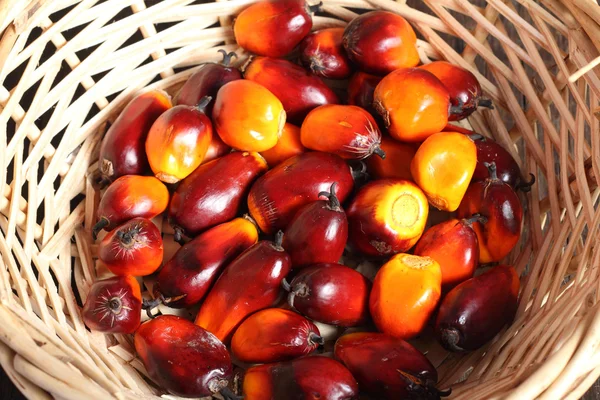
373;68;450;142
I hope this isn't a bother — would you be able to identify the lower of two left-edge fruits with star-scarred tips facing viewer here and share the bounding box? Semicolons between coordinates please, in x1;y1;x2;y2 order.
82;275;142;334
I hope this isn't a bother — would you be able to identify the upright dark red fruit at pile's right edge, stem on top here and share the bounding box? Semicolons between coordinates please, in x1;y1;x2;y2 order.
457;163;523;264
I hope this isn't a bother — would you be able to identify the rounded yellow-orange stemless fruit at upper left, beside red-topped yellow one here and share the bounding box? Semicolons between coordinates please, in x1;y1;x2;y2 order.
213;79;285;152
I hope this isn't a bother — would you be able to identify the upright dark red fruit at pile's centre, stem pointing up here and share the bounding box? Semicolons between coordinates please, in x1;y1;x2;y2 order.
283;183;348;268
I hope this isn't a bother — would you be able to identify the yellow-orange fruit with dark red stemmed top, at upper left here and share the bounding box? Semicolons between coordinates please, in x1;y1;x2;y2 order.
146;97;213;183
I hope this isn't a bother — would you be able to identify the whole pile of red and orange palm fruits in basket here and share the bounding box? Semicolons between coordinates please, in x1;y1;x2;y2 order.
83;0;531;400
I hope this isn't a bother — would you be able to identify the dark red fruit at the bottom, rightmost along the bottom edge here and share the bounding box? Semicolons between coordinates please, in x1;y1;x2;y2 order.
334;332;450;400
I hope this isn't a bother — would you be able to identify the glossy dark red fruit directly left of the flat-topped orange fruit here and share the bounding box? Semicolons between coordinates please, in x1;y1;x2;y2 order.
288;264;371;327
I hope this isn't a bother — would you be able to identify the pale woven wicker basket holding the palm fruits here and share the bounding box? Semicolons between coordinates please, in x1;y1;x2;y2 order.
0;0;600;400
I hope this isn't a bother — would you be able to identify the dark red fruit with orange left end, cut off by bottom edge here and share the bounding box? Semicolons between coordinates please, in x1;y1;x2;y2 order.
244;356;358;400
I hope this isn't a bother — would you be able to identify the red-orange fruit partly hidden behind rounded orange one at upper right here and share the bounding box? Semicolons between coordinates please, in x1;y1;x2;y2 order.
419;61;492;121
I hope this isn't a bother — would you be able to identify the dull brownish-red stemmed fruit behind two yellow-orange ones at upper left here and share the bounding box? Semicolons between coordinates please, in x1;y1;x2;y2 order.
175;50;242;115
